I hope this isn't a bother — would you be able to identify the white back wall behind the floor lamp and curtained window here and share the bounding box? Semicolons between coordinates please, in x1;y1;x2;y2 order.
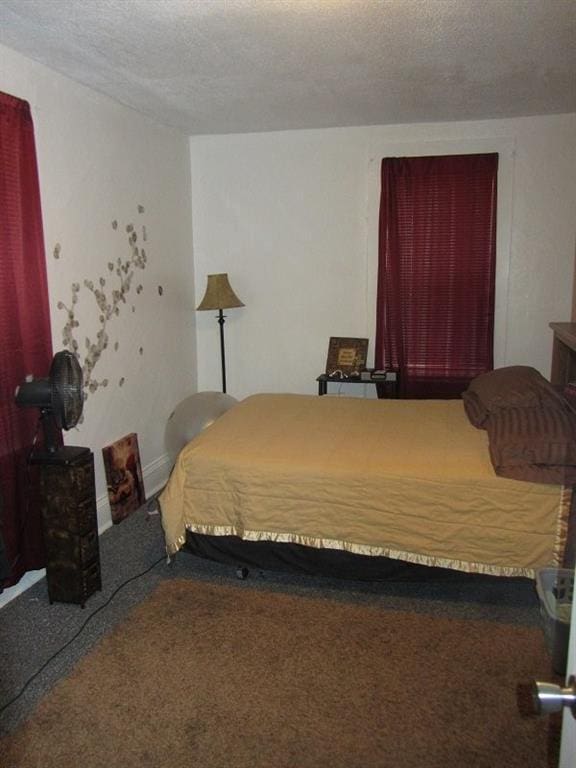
190;115;576;397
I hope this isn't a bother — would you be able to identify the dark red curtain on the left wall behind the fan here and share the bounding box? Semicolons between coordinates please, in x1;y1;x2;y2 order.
0;92;52;586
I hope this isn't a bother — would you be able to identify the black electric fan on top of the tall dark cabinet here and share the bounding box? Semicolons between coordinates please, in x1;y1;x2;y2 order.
16;350;84;453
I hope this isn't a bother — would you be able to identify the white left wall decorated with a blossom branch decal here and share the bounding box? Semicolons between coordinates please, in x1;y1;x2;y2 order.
0;47;197;529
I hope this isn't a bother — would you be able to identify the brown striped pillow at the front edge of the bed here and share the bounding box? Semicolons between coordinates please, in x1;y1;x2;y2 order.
486;408;576;485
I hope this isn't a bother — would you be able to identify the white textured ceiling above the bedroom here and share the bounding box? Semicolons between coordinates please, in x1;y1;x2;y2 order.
0;0;576;134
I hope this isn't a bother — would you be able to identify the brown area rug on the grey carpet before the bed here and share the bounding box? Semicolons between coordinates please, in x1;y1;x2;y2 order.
0;581;554;768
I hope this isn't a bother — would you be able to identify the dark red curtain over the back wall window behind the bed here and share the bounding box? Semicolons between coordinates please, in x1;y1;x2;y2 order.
375;154;498;398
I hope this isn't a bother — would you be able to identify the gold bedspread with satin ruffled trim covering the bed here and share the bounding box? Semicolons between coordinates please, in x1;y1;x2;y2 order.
160;395;572;576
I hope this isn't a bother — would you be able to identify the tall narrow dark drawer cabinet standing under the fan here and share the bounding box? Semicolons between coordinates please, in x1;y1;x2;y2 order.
33;446;102;607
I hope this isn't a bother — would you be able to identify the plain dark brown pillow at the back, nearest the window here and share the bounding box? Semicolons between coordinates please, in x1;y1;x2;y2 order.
462;365;566;428
